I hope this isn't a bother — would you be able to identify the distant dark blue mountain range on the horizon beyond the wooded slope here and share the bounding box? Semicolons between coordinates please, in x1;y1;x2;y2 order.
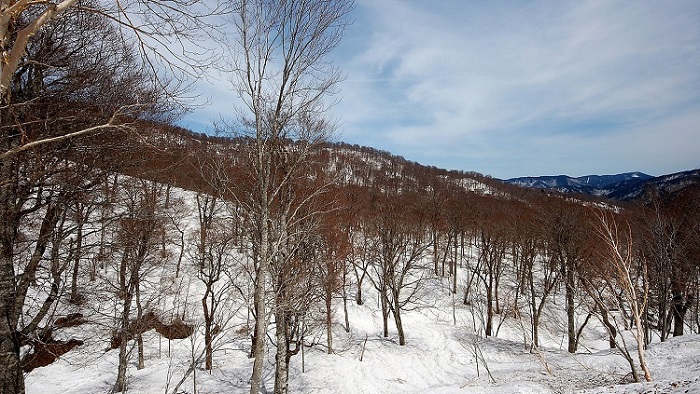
503;169;700;201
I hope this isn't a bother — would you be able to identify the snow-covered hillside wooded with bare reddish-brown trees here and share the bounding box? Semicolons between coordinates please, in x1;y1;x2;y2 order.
6;125;700;394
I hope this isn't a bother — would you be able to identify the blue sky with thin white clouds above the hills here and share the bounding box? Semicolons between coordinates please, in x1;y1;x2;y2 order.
182;0;700;178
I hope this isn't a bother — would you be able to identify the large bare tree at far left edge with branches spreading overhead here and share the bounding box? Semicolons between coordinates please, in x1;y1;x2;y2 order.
0;0;226;393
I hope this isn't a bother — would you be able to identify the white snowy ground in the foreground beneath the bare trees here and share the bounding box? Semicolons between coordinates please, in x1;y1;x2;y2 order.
26;270;700;394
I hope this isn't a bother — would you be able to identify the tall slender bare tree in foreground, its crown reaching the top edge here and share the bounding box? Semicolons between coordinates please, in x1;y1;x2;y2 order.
227;0;352;394
